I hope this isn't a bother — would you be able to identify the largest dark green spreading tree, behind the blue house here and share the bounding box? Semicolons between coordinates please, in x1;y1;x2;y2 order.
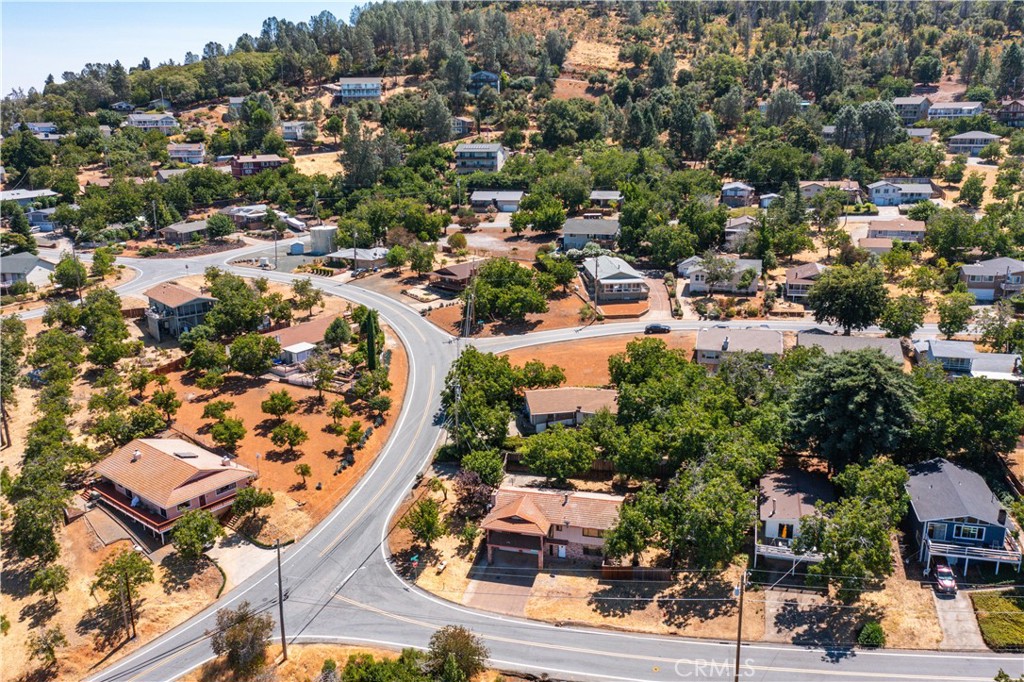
788;348;915;471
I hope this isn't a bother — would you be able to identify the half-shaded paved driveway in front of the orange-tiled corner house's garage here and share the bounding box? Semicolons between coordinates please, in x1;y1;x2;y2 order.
462;550;538;615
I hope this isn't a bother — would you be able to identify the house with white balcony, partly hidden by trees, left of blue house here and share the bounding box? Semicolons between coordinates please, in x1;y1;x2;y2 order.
754;468;836;565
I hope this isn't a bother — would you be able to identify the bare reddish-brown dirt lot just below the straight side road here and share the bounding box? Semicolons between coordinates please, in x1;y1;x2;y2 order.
506;332;696;386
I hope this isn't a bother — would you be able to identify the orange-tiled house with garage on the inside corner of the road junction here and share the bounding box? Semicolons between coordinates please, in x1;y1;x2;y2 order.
480;486;625;568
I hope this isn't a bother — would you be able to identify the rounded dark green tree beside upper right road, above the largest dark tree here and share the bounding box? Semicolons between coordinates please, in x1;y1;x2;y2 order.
807;263;888;336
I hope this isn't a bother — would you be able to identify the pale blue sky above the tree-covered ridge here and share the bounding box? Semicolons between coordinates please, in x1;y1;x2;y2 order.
0;0;356;95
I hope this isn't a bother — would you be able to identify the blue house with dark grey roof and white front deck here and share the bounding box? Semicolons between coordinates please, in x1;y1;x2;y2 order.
906;459;1021;572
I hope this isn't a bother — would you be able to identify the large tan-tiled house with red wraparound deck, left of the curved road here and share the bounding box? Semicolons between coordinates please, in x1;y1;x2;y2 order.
90;438;256;543
